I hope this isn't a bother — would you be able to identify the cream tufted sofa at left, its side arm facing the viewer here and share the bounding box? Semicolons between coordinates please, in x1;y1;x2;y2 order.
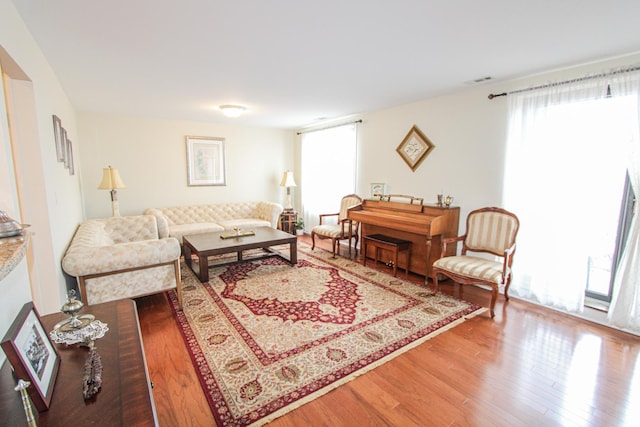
62;215;182;308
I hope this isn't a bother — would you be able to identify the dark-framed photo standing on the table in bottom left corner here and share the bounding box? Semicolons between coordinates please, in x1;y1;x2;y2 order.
2;301;60;412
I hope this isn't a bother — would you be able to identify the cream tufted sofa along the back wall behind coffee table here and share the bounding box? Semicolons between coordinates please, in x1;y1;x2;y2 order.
144;202;282;243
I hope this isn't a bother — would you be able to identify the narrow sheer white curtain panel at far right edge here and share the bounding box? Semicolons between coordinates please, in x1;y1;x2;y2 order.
608;73;640;333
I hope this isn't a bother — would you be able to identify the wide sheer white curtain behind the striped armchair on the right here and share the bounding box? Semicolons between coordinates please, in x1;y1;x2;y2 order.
504;73;637;312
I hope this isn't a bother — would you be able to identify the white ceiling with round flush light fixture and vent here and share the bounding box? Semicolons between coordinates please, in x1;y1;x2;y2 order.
13;0;640;129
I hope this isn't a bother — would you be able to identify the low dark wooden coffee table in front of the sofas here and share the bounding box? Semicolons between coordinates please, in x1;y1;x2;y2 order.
182;227;298;282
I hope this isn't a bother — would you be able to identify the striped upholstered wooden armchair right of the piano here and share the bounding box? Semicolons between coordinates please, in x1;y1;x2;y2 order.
432;207;520;318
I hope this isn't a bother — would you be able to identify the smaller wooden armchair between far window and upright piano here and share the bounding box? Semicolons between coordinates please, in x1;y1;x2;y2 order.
311;194;362;258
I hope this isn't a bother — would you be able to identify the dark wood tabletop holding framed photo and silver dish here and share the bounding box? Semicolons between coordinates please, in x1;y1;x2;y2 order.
0;300;158;427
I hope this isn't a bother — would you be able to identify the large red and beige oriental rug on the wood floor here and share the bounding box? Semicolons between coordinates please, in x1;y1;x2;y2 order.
169;243;486;426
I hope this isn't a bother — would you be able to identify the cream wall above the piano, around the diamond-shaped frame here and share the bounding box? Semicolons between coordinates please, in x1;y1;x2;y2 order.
358;54;640;224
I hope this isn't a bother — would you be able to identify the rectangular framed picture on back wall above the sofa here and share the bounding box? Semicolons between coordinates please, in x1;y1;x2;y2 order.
186;136;227;186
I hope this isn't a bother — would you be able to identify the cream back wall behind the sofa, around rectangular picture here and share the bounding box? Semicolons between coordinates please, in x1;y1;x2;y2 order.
78;112;293;218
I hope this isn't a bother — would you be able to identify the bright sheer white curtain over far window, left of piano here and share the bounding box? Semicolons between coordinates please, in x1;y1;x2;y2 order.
300;123;357;231
